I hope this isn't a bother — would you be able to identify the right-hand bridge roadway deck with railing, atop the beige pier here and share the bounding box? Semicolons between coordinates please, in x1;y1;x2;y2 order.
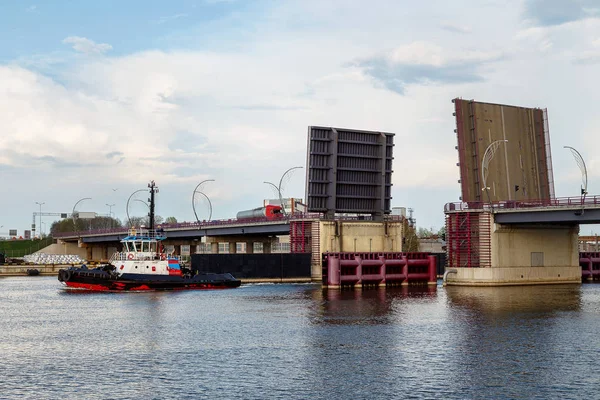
444;195;600;225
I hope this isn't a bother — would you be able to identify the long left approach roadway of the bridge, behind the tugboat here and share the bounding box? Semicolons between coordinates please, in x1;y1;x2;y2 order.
53;217;300;243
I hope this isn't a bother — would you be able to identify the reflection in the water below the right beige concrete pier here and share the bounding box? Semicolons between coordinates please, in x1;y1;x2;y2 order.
446;285;586;398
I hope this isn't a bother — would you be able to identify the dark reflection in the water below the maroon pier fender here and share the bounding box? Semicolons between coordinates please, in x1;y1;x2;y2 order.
303;286;437;399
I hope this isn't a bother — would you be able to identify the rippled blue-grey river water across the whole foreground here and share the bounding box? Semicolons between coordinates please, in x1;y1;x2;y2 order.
0;277;600;400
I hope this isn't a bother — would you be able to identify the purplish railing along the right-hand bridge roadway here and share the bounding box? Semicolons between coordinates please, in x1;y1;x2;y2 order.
444;195;600;212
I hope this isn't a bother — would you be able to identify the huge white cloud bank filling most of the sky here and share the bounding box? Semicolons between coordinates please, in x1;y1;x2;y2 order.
0;0;600;234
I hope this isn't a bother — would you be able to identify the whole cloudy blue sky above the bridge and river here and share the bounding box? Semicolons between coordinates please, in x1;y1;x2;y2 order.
0;0;600;236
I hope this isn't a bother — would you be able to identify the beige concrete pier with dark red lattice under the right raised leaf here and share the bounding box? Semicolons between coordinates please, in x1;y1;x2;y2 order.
446;211;581;286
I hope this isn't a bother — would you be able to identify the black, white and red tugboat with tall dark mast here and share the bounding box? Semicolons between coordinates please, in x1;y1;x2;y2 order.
58;181;241;291
